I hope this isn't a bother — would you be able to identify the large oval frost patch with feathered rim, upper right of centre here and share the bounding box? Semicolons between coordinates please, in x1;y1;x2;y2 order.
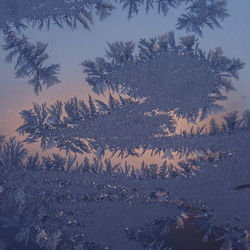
82;32;244;120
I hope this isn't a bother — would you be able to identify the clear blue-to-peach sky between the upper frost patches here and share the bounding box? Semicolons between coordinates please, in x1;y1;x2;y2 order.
0;0;250;141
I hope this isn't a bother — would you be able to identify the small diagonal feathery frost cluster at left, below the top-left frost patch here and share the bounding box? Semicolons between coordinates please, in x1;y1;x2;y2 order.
3;27;60;95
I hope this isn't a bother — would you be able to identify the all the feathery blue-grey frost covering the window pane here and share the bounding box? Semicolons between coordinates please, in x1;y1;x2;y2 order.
0;0;250;250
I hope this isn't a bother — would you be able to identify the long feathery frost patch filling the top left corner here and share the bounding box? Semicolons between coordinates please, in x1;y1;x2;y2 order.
0;0;114;30
